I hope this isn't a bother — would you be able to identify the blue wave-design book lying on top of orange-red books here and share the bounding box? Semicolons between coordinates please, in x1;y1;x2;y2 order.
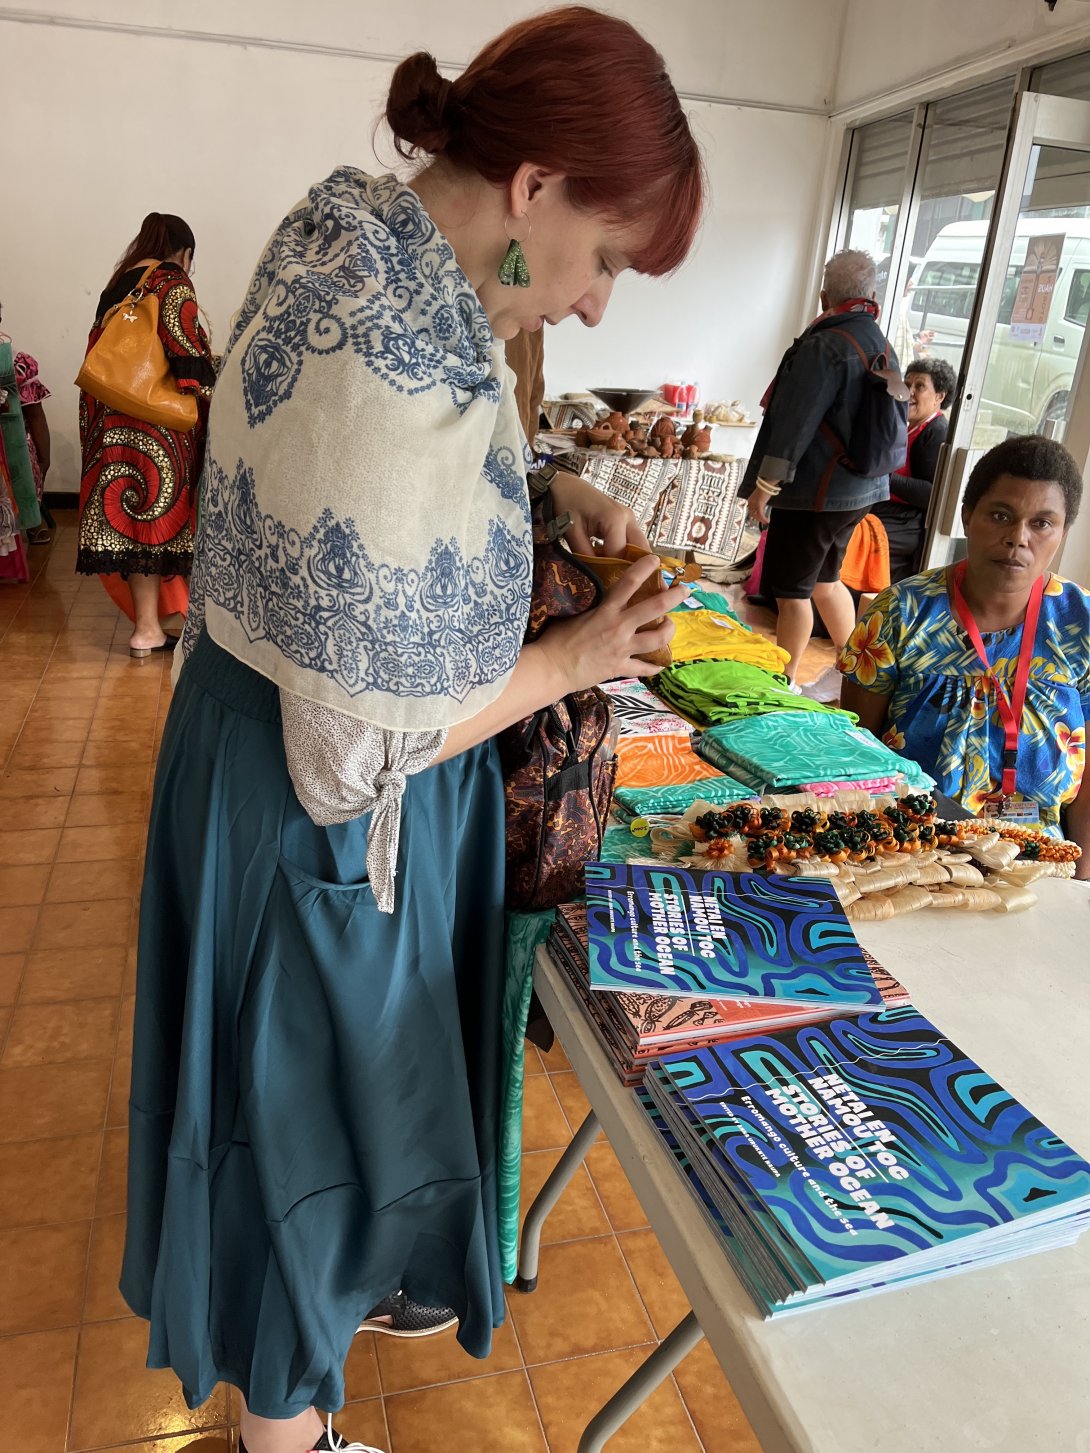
586;863;882;1011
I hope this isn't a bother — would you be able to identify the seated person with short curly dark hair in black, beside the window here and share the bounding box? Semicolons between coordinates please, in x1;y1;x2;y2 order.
871;359;958;586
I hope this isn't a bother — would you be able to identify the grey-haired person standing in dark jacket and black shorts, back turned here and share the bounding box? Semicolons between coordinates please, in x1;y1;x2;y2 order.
738;250;897;683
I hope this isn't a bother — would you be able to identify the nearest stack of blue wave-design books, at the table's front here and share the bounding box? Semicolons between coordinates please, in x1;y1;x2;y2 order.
648;1005;1090;1312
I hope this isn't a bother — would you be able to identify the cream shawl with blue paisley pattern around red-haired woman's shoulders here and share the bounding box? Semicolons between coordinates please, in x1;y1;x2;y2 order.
186;167;532;731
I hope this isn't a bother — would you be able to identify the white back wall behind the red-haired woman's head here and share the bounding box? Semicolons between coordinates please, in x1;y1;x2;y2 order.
0;0;844;490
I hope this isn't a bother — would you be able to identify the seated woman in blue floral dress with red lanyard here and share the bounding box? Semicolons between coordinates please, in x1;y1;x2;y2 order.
837;424;1090;878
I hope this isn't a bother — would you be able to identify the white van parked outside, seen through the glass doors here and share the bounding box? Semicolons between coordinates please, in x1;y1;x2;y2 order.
901;215;1090;434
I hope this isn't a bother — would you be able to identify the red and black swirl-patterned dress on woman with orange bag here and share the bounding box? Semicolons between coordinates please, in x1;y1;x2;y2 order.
76;263;215;575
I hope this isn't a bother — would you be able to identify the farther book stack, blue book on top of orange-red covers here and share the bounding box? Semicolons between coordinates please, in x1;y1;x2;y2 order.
546;863;907;1085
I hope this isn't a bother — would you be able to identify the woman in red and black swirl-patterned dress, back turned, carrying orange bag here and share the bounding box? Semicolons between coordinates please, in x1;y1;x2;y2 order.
76;212;215;657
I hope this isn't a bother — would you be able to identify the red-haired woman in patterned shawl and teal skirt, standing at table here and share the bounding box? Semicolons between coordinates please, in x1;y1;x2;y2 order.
122;7;703;1453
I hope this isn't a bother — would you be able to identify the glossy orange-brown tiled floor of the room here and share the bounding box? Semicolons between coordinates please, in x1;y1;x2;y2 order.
0;511;767;1453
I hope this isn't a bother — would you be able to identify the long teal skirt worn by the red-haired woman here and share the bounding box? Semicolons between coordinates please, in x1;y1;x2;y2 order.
121;635;504;1418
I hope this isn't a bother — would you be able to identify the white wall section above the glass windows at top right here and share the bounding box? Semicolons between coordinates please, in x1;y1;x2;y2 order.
834;0;1090;110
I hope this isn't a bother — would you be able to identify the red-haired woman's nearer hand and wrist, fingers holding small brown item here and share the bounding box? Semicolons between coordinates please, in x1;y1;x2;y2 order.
536;555;690;697
